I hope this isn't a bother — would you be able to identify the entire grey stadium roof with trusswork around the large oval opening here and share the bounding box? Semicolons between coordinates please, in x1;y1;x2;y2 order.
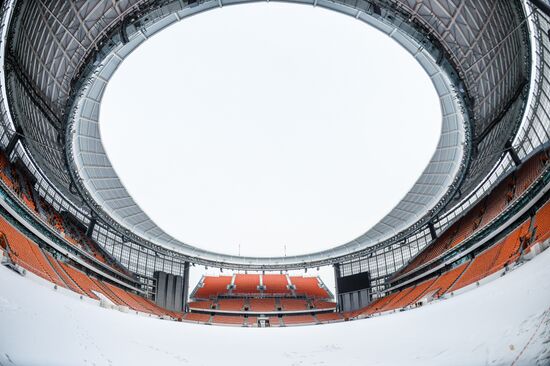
1;0;531;268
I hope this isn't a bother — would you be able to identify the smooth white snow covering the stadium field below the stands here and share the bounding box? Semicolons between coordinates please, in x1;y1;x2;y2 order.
0;250;550;366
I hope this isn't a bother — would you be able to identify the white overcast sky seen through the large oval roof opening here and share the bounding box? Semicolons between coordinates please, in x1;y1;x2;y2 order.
101;2;441;288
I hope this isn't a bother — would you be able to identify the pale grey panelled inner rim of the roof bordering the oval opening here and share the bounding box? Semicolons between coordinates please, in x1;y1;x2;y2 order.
66;0;470;268
